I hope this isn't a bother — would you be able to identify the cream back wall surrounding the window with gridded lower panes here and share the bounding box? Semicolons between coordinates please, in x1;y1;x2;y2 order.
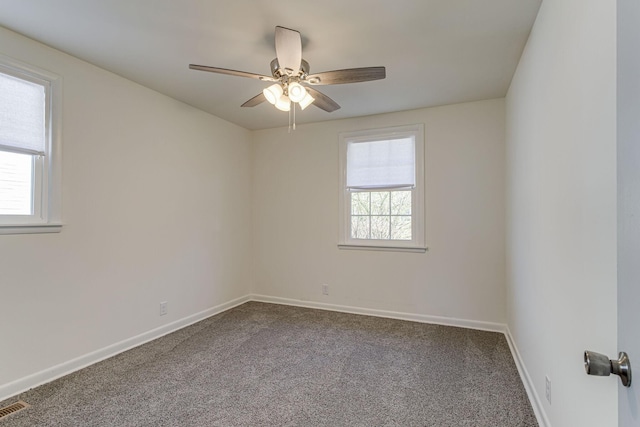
253;100;506;323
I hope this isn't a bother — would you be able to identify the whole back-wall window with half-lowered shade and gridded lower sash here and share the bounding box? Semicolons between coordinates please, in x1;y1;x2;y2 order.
338;124;426;252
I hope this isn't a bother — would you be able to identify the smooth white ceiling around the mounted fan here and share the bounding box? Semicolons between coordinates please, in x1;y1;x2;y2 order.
0;0;542;129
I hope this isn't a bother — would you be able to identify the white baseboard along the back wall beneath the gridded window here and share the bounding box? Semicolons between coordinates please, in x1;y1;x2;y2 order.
251;294;506;333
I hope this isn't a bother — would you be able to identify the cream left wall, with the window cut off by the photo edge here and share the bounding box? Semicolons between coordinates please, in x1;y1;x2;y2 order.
0;28;251;395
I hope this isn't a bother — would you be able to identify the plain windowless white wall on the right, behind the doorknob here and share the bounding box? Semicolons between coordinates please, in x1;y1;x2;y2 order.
506;0;617;427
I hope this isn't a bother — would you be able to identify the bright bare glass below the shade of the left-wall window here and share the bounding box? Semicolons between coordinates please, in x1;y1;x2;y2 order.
0;151;33;215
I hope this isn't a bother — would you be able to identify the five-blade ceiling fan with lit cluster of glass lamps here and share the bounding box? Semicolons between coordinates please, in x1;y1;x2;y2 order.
189;26;386;113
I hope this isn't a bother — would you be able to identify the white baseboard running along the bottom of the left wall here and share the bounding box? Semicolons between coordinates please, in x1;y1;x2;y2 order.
0;295;251;401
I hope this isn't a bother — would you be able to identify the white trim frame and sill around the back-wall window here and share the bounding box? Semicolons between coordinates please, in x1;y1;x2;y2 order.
338;124;427;252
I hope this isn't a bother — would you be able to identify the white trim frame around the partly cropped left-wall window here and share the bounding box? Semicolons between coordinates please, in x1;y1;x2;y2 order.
0;54;62;235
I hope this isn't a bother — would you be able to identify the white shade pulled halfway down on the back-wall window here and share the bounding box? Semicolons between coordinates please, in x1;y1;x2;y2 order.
346;136;416;189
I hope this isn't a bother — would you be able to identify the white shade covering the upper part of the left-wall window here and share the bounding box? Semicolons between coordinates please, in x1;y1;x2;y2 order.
0;73;46;155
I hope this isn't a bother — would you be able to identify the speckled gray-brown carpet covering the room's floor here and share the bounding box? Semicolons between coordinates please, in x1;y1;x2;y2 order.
0;302;537;427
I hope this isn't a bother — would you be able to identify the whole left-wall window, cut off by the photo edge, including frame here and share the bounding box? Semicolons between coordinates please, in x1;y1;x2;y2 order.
0;56;61;234
